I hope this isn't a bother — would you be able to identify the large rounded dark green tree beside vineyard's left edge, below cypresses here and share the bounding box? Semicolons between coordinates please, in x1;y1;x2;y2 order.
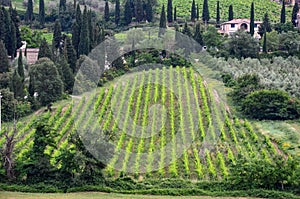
30;58;63;106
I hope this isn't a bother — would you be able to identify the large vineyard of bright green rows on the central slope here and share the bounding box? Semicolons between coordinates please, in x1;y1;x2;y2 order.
0;67;283;180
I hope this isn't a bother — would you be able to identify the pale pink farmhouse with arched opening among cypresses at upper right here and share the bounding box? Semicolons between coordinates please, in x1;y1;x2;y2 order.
219;19;262;38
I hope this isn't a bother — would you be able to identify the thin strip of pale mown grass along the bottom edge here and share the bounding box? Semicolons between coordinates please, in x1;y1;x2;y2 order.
0;192;260;199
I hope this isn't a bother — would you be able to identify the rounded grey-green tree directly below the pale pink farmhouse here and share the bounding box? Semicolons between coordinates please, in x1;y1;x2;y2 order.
225;30;259;59
